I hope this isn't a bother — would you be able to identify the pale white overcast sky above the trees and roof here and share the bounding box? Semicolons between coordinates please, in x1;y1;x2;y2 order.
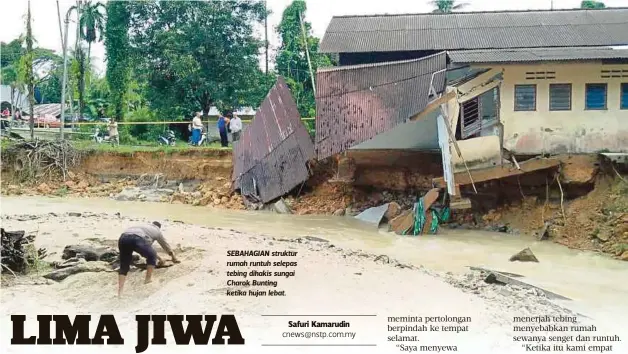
0;0;628;72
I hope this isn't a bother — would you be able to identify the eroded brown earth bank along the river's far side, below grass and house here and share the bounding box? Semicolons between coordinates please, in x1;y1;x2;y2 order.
2;150;628;260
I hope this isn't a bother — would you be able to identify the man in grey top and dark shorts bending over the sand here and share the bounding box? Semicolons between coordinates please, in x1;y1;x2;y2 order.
118;221;179;297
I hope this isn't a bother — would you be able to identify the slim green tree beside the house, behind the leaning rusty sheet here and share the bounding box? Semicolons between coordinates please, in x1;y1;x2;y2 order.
276;0;332;117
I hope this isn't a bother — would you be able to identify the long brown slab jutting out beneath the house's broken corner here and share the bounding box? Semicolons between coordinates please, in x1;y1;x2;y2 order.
432;158;560;188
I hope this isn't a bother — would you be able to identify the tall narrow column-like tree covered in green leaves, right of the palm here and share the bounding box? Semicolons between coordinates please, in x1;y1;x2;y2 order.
105;1;131;120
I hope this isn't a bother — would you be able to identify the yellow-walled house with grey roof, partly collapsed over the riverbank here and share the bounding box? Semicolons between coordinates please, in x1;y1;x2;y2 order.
316;8;628;195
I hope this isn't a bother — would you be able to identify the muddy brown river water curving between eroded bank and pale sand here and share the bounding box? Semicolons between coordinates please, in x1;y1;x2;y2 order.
0;197;628;314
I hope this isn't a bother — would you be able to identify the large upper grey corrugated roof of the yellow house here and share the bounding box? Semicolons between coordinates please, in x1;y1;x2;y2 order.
320;8;628;53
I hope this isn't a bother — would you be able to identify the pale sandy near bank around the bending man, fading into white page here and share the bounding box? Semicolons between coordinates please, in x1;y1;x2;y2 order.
2;207;621;353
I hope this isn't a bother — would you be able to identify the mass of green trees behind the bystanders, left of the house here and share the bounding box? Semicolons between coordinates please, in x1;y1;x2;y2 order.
1;0;333;145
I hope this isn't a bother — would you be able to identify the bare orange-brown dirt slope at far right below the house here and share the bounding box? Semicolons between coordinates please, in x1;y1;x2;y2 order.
457;176;628;260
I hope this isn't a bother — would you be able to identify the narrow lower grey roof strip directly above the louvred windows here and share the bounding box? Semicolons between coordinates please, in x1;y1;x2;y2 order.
447;47;628;63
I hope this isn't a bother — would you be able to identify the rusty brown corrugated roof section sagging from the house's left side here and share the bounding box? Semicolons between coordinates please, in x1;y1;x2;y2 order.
316;52;447;159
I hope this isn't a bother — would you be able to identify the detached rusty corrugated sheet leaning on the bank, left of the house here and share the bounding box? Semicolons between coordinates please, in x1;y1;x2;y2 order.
232;77;315;203
